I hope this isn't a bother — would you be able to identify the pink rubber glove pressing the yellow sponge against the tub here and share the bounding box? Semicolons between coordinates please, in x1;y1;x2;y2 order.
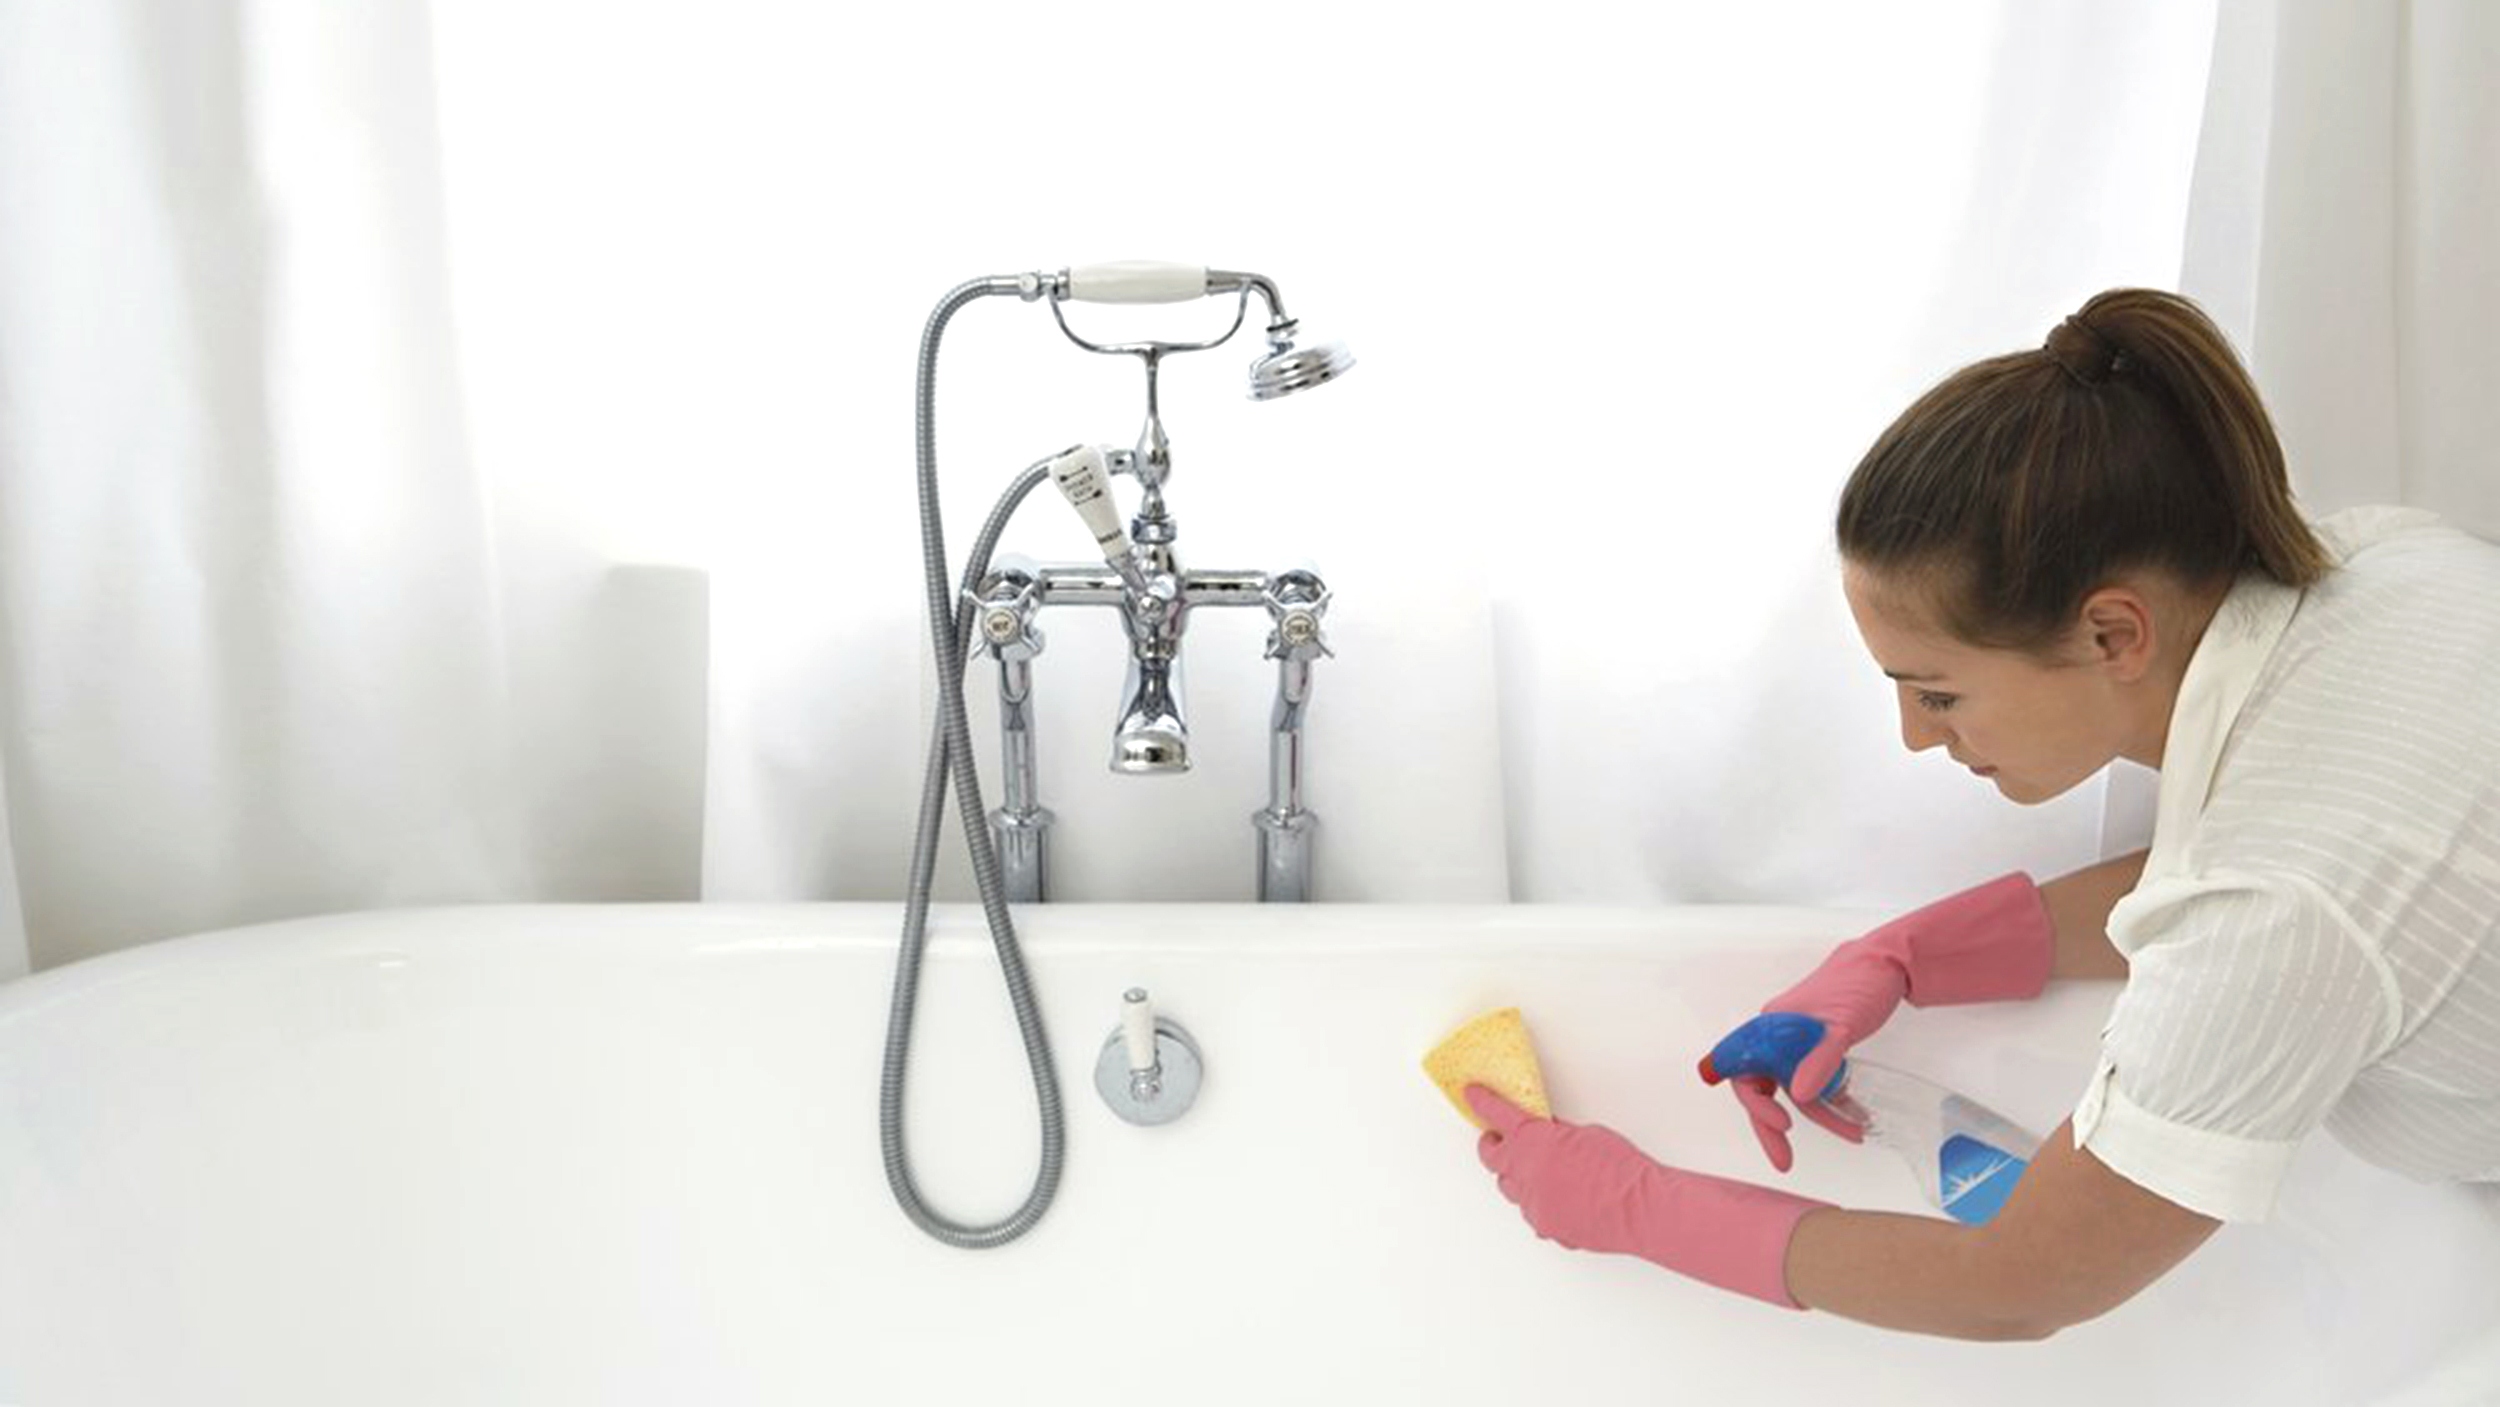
1468;1085;1830;1310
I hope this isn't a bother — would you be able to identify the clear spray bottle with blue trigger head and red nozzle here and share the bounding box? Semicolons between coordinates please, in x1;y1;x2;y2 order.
1703;1012;2043;1227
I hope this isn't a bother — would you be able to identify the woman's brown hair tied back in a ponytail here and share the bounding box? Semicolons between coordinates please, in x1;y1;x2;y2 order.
1838;287;2330;650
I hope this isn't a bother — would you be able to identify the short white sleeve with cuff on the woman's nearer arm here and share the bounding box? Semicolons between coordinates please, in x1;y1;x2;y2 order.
2075;880;2398;1222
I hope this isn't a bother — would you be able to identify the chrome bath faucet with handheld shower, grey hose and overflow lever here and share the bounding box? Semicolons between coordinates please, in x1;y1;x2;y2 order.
878;265;1355;1250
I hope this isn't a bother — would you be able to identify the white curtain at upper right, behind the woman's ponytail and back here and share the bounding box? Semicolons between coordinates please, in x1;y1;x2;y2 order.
2180;0;2500;537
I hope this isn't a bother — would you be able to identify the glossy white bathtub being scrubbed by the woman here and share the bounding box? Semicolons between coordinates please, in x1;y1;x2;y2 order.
0;905;2500;1407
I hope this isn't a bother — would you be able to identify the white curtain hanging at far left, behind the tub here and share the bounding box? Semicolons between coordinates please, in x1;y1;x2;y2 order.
0;0;700;965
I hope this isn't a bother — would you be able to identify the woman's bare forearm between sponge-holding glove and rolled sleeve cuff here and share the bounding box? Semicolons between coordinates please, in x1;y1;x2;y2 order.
1788;1124;2223;1340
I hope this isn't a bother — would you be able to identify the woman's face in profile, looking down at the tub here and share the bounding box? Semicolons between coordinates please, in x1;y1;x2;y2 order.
1840;562;2158;805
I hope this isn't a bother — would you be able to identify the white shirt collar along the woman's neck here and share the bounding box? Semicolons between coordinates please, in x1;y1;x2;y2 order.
2145;572;2303;875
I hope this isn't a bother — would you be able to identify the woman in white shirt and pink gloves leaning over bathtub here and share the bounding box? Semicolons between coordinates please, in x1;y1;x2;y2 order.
1468;290;2500;1340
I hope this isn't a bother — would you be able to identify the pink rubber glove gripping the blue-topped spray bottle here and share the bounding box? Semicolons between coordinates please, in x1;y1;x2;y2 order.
1705;872;2058;1172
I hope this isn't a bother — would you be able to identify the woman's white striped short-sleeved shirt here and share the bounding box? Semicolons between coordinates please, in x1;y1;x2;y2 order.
2075;510;2500;1220
